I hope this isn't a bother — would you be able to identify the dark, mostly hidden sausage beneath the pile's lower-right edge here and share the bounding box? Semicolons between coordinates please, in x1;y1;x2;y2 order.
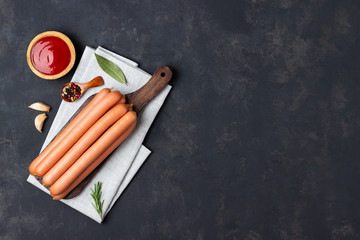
53;122;136;200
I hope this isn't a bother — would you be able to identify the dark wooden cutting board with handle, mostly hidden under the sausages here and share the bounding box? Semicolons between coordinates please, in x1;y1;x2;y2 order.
35;66;172;199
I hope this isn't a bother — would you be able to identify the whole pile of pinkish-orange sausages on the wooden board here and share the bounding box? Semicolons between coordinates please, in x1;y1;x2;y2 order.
29;88;137;200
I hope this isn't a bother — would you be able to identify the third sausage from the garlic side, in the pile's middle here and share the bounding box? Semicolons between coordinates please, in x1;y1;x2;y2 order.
43;104;128;186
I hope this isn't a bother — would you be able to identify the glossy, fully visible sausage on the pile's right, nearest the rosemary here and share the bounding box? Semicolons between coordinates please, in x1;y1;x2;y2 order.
50;111;136;195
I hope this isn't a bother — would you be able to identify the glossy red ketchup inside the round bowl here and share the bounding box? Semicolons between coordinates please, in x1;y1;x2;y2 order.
31;37;71;75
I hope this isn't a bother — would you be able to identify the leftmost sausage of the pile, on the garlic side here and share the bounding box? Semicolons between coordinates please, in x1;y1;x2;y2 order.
29;88;110;175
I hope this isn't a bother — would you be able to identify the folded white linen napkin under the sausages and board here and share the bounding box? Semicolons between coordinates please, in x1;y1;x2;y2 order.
27;47;171;223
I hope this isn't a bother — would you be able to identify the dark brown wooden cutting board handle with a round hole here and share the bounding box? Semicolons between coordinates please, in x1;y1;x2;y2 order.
126;66;172;112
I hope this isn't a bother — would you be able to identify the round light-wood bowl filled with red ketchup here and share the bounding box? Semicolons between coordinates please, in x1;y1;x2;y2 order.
26;31;75;80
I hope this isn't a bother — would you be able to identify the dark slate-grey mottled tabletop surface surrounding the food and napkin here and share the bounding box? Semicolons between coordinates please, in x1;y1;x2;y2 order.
0;0;360;240
